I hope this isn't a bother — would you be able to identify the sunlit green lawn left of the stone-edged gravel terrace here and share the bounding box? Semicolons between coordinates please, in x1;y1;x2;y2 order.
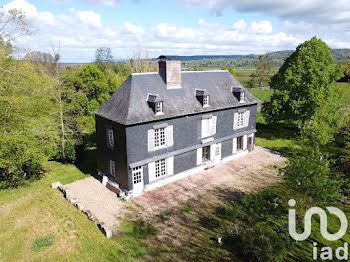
0;162;153;262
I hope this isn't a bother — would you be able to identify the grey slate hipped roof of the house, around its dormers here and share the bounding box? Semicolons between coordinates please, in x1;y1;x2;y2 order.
95;70;260;125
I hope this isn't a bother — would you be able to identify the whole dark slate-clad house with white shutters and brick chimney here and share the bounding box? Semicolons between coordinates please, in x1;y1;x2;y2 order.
95;56;259;196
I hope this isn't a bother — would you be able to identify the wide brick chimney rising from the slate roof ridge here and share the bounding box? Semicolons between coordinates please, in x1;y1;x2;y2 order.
158;56;181;89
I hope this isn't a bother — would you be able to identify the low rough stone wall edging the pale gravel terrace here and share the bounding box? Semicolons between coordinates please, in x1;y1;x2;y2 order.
51;181;112;238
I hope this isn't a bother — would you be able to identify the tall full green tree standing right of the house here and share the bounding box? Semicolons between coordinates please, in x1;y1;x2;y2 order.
262;37;341;132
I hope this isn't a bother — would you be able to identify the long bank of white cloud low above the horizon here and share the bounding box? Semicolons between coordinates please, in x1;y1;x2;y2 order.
5;0;350;62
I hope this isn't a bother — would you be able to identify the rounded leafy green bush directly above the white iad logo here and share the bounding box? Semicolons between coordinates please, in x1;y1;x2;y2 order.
284;148;344;201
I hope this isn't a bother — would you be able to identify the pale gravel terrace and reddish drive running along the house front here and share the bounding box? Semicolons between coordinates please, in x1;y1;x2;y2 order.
65;147;284;232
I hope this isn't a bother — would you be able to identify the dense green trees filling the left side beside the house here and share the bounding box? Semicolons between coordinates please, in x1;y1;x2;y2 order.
0;8;160;189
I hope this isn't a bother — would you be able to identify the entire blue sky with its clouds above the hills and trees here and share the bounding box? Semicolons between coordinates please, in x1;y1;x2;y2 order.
1;0;350;62
